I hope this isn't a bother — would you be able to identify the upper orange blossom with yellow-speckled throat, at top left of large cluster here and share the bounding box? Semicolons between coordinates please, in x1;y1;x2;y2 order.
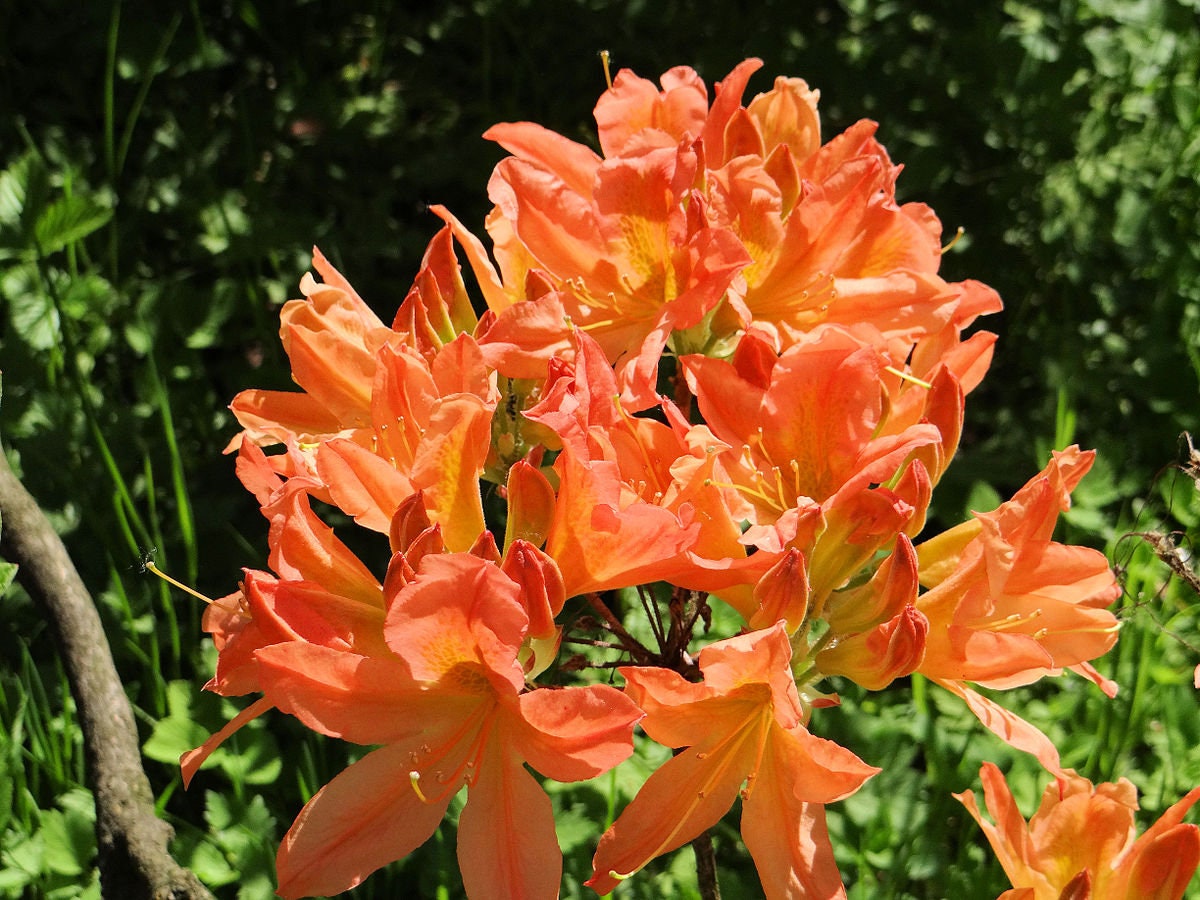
472;116;750;409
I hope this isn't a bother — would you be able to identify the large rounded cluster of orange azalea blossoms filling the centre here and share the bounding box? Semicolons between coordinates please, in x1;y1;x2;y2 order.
184;60;1166;898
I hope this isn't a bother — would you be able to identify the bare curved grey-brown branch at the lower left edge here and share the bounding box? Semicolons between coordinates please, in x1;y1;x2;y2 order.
0;452;212;900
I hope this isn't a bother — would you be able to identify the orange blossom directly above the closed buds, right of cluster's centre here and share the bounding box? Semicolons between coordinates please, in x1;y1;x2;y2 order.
682;329;936;629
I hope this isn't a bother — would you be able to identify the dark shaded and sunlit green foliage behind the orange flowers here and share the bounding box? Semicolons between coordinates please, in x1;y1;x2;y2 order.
0;0;1200;898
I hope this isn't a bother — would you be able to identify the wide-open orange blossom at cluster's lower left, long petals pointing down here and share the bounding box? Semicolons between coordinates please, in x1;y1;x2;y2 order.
256;553;641;900
